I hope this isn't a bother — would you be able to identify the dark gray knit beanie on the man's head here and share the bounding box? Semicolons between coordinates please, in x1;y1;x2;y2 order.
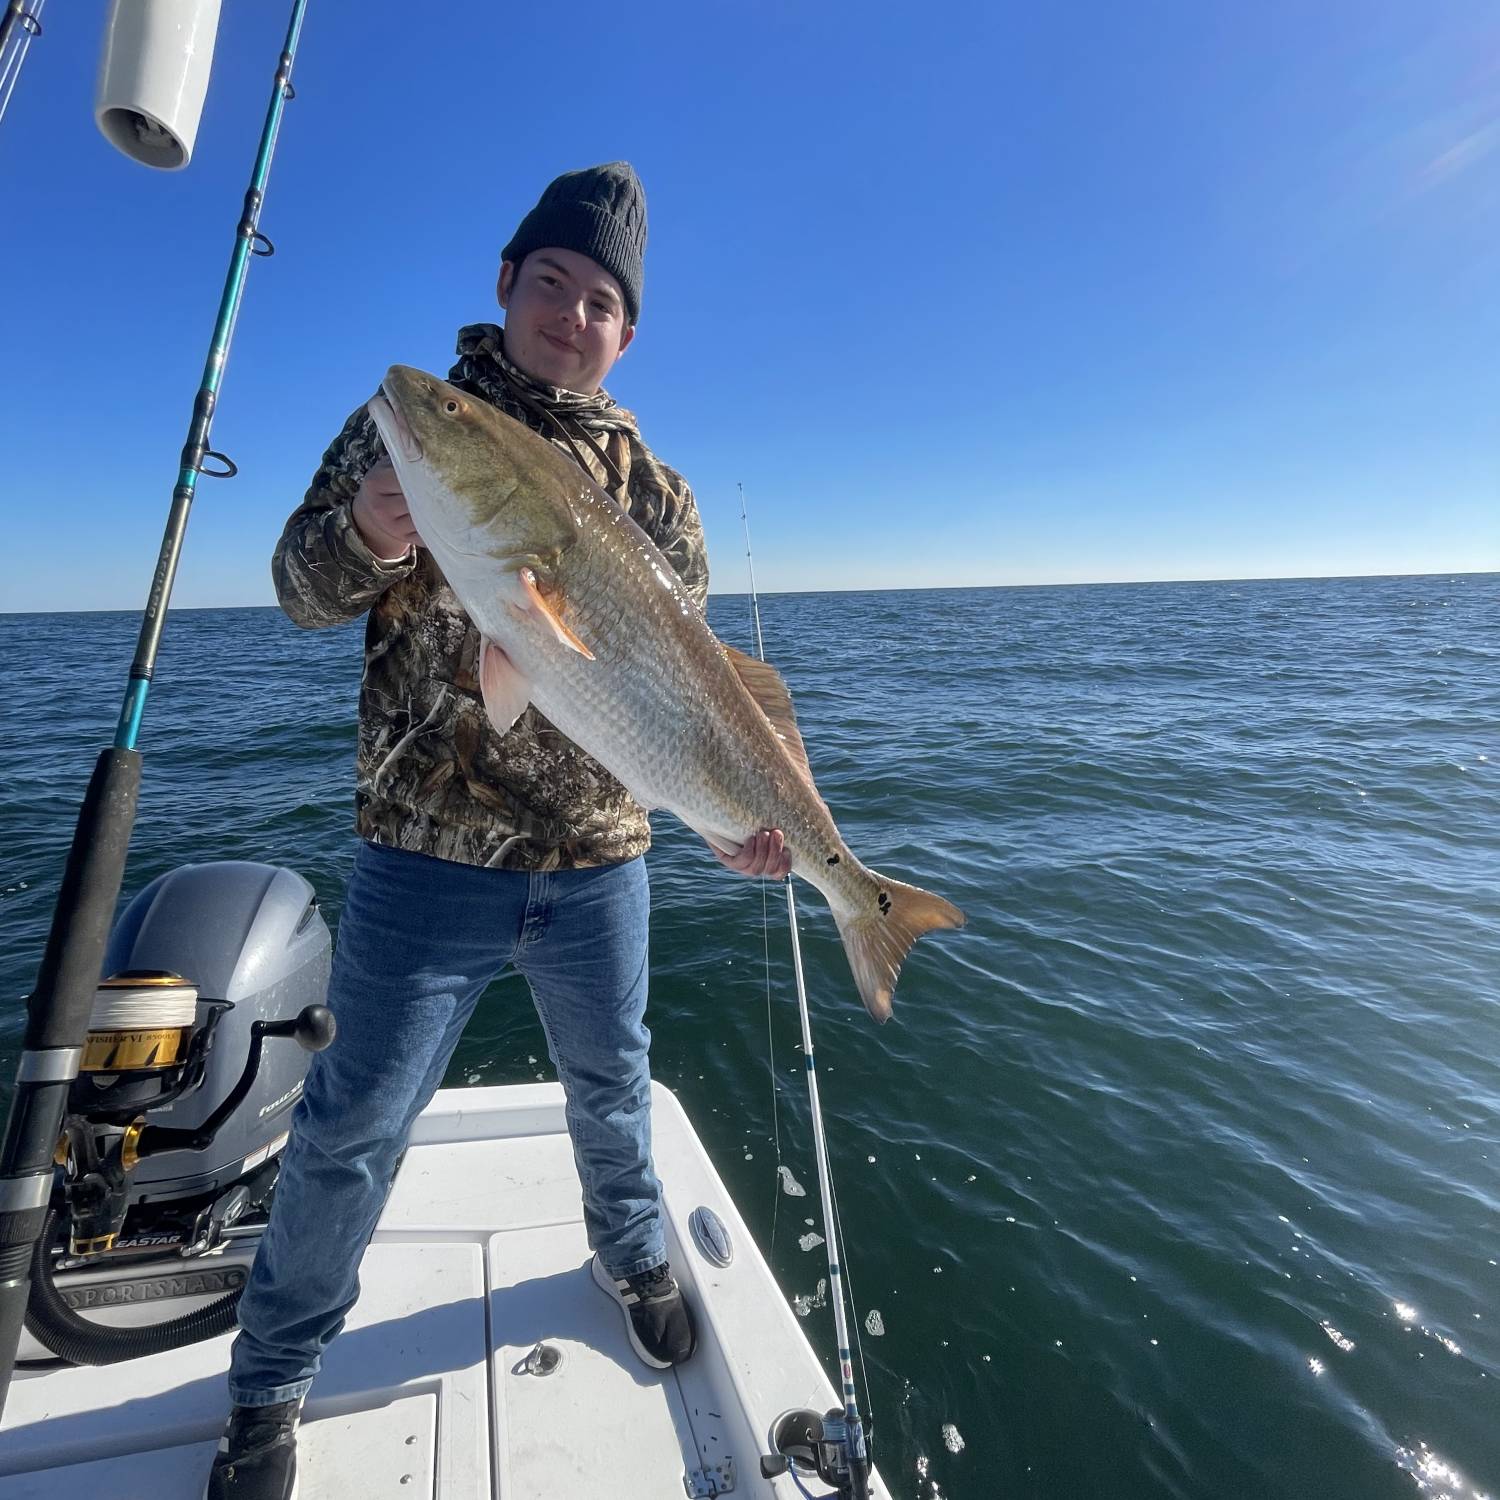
500;162;647;324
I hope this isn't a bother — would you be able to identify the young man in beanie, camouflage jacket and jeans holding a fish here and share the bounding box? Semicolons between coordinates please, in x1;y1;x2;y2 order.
217;162;789;1500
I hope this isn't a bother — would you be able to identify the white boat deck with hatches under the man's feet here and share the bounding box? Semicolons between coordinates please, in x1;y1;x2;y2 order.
0;1083;888;1500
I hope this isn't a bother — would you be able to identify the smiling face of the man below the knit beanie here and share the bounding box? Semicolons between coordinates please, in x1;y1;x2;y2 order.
497;248;636;396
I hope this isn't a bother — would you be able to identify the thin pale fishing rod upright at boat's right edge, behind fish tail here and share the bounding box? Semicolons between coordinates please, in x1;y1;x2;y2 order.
740;485;870;1500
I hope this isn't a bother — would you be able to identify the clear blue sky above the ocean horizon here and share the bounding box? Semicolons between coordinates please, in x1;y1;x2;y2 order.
0;0;1500;609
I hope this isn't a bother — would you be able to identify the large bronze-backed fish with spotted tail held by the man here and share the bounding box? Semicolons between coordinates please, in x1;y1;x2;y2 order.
371;365;963;1020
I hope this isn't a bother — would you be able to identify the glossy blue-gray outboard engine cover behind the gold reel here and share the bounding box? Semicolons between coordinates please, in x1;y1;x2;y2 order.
104;860;333;1202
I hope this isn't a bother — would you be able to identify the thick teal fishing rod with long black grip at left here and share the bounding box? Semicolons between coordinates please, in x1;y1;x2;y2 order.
0;0;308;1415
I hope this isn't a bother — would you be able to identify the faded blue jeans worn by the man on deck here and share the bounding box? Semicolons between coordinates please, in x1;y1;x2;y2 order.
230;843;666;1406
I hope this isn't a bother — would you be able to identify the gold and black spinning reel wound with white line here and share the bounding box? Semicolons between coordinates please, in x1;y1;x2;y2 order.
57;971;333;1262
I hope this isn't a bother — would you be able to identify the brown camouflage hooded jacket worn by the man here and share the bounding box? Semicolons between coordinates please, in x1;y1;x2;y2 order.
272;323;708;870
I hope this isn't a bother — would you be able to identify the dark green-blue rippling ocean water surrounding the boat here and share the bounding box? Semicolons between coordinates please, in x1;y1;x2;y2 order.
0;575;1500;1500
